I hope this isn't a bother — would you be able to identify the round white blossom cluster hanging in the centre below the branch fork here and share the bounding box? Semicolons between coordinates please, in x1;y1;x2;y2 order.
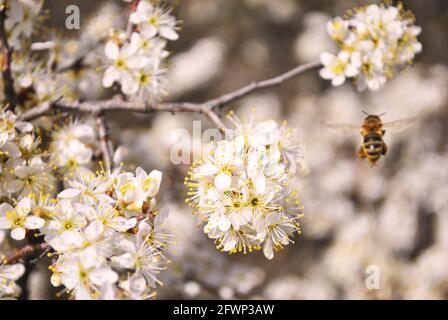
186;113;303;259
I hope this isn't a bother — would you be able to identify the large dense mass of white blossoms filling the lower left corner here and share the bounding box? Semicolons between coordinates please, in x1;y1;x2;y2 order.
0;168;171;299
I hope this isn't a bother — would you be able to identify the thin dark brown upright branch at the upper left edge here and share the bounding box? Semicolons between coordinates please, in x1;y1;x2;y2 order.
0;2;19;110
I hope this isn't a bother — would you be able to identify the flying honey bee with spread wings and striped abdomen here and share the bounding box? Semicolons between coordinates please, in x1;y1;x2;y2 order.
327;111;417;166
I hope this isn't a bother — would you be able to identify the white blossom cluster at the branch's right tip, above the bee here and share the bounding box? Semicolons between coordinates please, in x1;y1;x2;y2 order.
320;4;422;91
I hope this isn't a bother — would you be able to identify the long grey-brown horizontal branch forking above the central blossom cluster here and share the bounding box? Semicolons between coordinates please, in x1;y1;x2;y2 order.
20;61;321;130
